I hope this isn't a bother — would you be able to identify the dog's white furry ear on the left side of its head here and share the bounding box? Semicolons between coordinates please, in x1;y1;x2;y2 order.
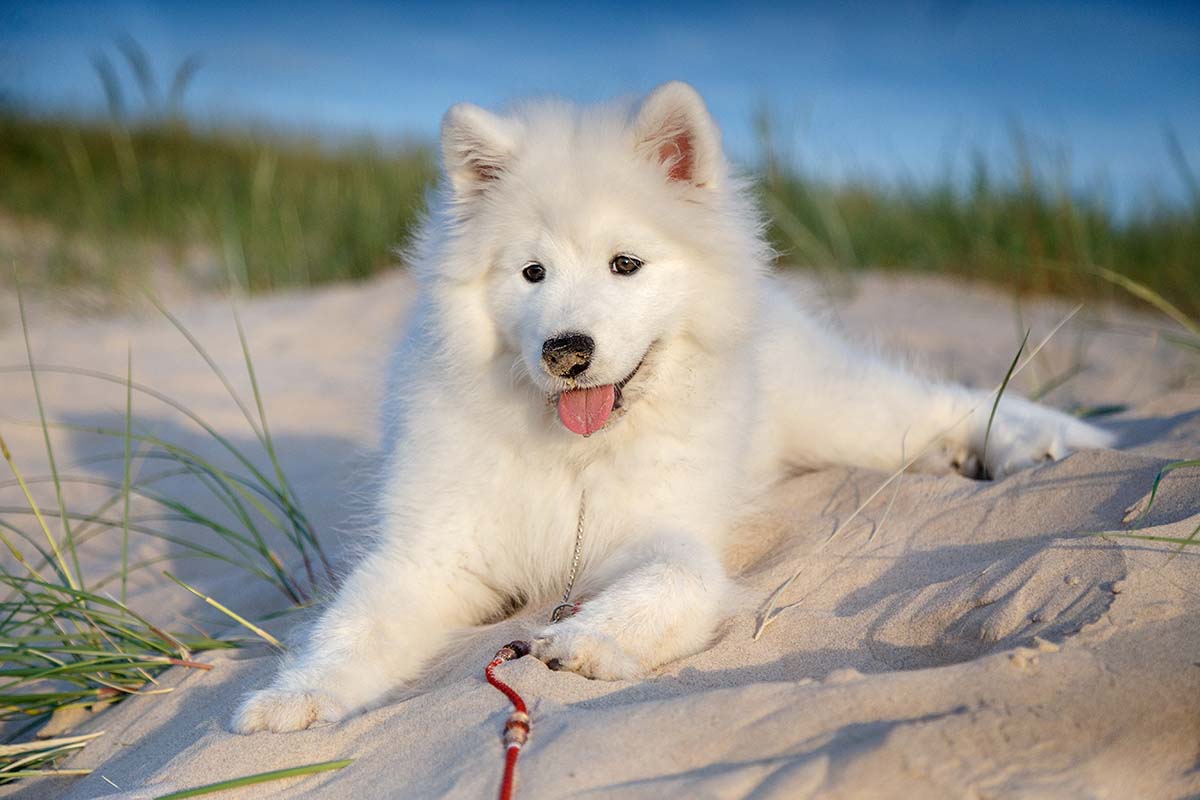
442;103;518;200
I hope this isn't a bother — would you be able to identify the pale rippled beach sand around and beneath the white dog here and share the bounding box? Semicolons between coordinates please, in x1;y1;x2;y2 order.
0;273;1200;800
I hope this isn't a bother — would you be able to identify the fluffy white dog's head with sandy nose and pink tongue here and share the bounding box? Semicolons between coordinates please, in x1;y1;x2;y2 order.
434;83;763;435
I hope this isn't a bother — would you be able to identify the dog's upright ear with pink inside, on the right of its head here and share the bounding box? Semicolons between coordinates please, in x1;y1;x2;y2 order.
634;80;724;188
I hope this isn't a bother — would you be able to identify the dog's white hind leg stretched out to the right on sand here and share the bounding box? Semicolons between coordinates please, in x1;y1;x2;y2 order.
762;304;1114;477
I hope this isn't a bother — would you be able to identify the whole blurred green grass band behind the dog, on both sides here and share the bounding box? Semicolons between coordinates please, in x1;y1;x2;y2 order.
0;109;1200;323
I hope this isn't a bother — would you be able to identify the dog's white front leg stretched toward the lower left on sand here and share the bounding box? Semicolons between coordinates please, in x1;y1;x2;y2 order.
233;552;494;733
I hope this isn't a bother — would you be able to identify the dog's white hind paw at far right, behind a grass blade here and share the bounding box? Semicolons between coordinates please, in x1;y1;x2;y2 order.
982;398;1116;479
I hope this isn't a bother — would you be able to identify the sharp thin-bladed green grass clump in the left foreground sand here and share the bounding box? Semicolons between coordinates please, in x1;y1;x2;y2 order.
0;286;332;783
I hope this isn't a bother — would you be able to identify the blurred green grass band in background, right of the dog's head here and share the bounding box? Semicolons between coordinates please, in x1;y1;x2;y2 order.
758;121;1200;319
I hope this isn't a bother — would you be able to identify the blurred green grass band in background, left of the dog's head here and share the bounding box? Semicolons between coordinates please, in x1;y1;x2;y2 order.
0;114;433;293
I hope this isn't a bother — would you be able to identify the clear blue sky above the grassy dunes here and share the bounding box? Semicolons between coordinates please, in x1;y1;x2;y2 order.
0;0;1200;204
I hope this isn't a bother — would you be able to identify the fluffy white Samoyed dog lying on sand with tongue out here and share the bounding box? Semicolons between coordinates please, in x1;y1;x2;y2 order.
233;83;1112;733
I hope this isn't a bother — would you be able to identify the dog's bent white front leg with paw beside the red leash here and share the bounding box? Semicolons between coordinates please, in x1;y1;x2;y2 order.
533;535;730;680
